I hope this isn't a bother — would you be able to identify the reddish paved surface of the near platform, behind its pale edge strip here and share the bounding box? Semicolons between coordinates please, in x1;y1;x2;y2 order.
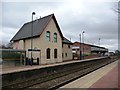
90;66;118;88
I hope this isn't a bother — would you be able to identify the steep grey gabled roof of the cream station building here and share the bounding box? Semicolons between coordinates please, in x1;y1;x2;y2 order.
10;14;63;41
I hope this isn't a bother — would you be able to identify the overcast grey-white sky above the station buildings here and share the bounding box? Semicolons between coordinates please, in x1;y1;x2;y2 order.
0;0;118;51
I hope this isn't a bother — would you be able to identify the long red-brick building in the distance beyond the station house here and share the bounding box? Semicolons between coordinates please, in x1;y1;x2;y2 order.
72;42;108;59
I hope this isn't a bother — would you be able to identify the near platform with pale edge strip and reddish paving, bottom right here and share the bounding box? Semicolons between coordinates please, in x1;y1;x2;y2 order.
58;61;118;90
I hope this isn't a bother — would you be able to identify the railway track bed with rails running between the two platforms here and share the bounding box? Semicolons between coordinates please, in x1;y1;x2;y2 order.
2;58;117;90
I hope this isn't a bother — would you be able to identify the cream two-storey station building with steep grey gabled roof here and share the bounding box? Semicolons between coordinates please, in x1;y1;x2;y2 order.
11;14;72;64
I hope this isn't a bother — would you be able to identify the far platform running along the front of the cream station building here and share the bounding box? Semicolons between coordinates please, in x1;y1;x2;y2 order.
0;57;106;74
